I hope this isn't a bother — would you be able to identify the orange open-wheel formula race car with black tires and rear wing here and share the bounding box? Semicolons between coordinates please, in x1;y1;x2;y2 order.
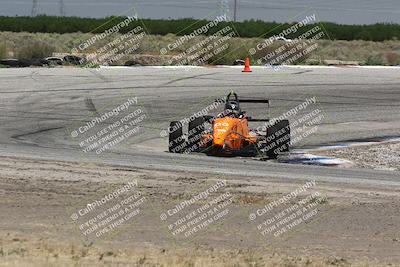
169;92;290;158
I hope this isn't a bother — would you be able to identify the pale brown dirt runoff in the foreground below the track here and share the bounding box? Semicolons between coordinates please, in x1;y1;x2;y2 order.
0;157;400;267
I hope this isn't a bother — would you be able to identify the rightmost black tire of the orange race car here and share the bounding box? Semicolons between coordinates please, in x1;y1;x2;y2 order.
266;120;290;159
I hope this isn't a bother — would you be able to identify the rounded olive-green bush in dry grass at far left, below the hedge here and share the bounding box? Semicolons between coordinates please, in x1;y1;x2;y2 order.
16;41;55;59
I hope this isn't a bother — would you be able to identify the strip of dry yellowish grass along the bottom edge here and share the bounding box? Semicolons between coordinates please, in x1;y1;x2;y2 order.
0;236;399;267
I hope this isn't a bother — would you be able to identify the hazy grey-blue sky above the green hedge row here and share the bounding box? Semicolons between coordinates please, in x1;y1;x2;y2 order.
0;0;400;24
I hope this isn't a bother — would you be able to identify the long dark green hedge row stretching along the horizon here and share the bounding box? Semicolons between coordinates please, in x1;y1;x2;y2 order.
0;15;400;41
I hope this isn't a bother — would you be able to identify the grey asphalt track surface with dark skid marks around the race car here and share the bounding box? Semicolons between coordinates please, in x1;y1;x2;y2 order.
0;67;400;187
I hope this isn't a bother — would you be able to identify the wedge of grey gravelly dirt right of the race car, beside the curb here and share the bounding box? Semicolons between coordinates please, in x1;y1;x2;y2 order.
313;142;400;171
